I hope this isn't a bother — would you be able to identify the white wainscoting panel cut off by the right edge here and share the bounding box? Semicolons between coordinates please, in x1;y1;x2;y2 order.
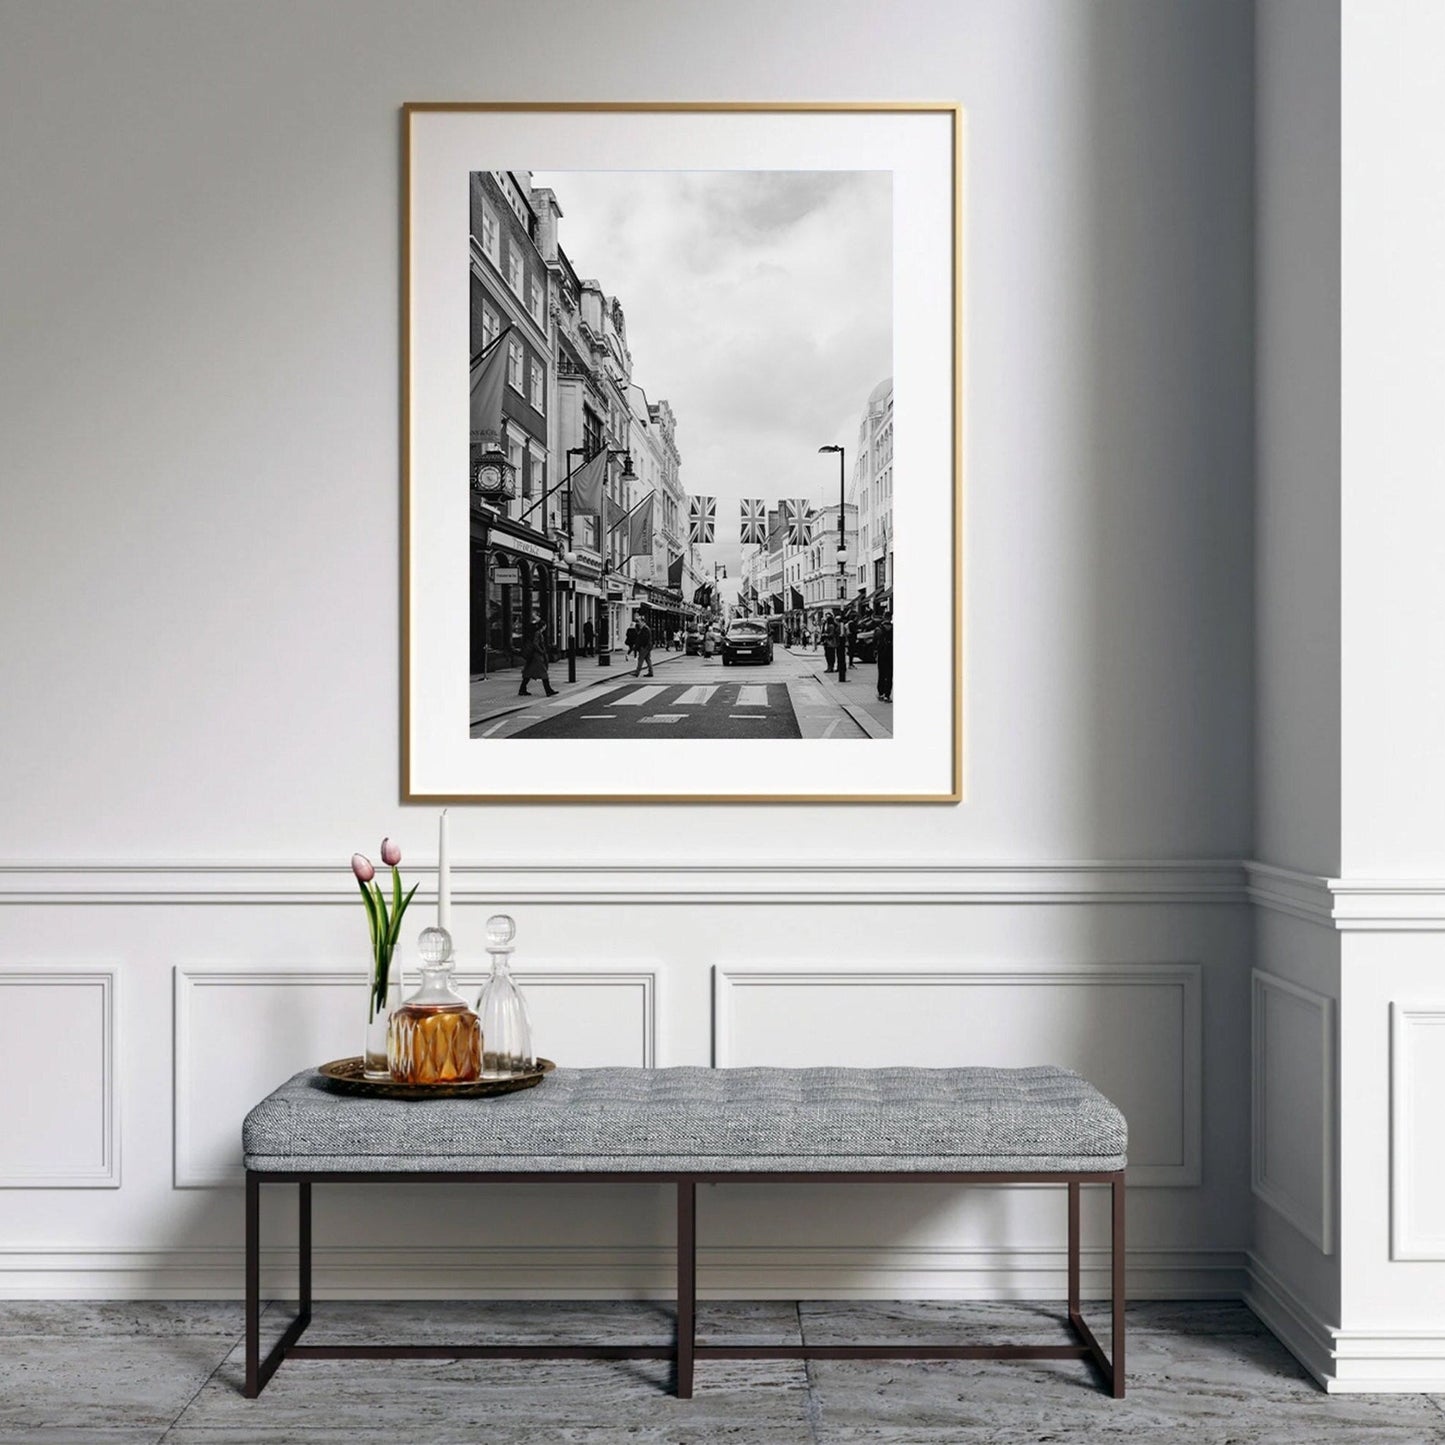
1390;1001;1445;1260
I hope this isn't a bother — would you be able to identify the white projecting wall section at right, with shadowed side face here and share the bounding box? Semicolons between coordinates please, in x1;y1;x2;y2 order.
1250;0;1445;1392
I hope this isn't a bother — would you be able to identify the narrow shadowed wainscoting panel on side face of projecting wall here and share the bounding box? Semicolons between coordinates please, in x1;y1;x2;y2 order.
1250;968;1335;1254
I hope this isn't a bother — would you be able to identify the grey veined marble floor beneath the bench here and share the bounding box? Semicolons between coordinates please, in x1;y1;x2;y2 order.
0;1301;1445;1445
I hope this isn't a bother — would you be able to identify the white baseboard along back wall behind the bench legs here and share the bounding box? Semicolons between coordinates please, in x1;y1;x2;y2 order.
0;1246;1246;1299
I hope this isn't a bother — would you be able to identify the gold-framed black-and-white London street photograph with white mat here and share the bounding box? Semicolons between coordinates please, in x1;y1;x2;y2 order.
402;103;964;803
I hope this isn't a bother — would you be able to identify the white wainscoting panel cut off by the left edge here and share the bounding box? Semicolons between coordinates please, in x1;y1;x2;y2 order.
0;967;120;1189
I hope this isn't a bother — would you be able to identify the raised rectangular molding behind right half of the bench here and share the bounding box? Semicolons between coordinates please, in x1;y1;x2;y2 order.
712;962;1204;1188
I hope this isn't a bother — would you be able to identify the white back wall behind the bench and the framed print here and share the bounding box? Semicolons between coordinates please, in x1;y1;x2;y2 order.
0;0;1254;1293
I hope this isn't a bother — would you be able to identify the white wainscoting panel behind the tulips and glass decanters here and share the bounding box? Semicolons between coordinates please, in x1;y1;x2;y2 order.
173;964;657;1189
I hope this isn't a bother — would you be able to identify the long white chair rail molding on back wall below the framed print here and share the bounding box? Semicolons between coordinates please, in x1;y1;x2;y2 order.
0;858;1247;907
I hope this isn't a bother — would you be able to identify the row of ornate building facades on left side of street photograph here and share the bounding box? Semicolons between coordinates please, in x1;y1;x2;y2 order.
470;171;701;675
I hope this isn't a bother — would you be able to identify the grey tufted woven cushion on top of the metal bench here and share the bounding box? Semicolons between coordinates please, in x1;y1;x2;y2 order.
243;1068;1127;1173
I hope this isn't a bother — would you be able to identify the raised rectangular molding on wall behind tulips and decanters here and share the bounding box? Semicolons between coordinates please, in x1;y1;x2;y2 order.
171;964;657;1189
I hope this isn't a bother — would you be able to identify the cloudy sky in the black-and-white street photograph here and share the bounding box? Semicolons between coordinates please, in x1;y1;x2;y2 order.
532;171;893;577
